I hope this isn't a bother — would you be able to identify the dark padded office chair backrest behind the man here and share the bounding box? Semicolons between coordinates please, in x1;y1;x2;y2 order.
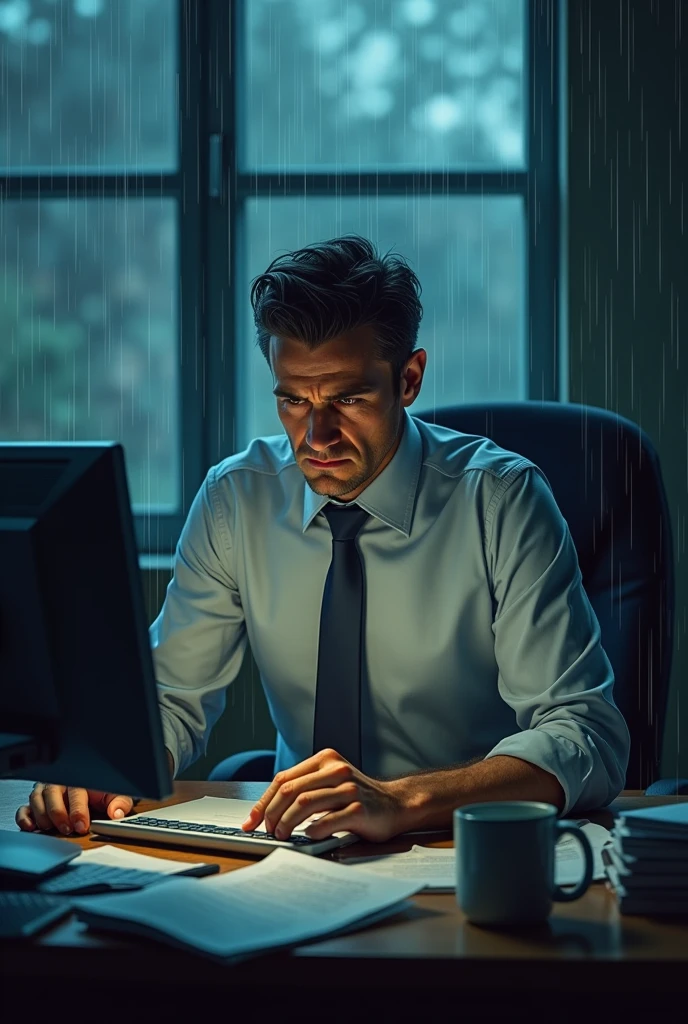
410;401;674;790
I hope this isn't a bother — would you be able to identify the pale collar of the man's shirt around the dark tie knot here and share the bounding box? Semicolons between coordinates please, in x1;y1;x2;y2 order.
303;409;423;537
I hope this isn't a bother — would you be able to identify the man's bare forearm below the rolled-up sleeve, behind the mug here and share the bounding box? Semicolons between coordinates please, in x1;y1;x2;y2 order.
389;755;565;831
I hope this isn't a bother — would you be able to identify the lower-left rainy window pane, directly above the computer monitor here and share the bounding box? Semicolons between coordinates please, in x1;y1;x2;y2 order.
0;199;181;511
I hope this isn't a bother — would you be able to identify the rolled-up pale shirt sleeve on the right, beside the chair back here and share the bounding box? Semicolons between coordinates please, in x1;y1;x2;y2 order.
485;464;631;814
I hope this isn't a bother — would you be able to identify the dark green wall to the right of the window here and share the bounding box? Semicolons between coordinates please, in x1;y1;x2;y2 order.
567;0;688;776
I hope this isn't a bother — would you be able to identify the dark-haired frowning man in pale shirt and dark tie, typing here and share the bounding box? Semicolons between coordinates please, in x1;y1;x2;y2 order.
16;236;630;841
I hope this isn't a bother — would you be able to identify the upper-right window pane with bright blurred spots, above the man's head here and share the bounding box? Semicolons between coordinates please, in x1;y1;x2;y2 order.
243;0;525;171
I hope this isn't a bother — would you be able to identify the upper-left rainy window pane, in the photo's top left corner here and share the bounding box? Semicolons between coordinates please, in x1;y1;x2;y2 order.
0;0;178;172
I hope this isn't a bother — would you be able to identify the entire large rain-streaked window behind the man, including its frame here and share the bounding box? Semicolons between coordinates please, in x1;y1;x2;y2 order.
0;0;560;553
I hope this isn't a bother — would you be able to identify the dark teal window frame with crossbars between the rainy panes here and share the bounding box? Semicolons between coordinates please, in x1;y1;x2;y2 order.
0;0;565;565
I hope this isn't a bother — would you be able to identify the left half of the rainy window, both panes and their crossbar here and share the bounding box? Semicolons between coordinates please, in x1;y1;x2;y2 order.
0;0;181;544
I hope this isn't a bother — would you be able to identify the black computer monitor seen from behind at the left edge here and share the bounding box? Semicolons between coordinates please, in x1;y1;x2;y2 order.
0;441;172;800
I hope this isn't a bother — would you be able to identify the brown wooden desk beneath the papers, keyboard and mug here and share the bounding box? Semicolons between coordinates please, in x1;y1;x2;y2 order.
0;780;688;1024
